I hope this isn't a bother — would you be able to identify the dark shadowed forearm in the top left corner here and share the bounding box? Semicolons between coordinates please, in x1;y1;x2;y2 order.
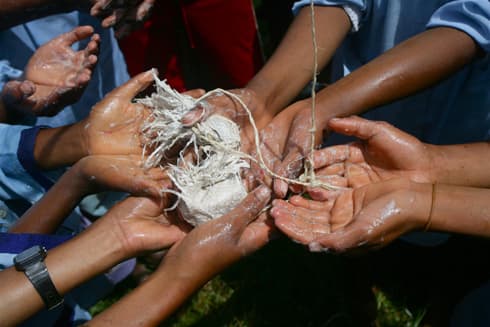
0;0;88;29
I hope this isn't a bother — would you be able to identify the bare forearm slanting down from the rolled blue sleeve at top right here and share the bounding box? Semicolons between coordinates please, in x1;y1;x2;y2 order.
317;27;480;123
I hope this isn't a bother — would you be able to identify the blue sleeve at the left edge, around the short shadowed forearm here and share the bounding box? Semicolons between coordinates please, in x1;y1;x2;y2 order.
0;124;45;203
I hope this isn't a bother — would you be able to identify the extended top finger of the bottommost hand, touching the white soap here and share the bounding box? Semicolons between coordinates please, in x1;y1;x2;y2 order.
226;186;271;234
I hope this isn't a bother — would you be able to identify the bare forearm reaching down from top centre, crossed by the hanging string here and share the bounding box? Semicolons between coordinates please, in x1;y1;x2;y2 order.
247;6;351;114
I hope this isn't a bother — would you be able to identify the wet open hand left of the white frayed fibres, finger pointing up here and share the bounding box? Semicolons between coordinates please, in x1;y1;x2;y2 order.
77;71;153;155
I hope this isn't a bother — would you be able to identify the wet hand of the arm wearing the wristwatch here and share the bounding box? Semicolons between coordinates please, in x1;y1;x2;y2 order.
91;197;186;257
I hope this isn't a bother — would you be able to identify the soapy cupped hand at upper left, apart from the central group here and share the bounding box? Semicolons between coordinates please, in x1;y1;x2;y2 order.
2;26;100;116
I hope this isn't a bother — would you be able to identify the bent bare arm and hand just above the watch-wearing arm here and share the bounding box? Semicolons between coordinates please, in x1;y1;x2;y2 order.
9;156;170;234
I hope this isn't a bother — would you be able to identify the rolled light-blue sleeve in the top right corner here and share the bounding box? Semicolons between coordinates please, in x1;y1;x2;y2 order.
427;0;490;52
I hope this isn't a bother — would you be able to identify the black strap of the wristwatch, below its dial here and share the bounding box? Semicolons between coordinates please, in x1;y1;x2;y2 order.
25;261;63;310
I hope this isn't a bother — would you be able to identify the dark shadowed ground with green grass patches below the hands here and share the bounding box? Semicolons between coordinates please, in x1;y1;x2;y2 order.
92;239;424;327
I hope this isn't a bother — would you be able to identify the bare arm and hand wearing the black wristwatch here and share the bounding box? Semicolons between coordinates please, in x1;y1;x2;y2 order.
0;198;184;326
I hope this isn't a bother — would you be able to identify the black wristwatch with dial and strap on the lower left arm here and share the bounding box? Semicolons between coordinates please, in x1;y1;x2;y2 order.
14;245;63;310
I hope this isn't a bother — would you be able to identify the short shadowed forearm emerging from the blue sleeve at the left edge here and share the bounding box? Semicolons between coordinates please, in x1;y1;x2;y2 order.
34;123;86;170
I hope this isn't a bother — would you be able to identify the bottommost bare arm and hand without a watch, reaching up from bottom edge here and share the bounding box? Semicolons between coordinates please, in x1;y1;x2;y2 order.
88;187;270;326
